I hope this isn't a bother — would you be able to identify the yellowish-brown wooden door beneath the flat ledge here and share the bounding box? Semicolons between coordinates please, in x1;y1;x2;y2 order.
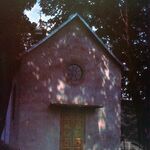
60;108;85;150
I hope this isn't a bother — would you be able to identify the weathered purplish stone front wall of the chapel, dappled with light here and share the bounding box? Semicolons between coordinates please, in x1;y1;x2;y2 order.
11;15;121;150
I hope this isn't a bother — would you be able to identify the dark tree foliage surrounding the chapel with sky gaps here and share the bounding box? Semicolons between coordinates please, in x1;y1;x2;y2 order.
0;0;150;149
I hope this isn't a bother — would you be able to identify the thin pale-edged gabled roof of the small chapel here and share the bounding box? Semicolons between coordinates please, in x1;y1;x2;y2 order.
27;13;128;70
